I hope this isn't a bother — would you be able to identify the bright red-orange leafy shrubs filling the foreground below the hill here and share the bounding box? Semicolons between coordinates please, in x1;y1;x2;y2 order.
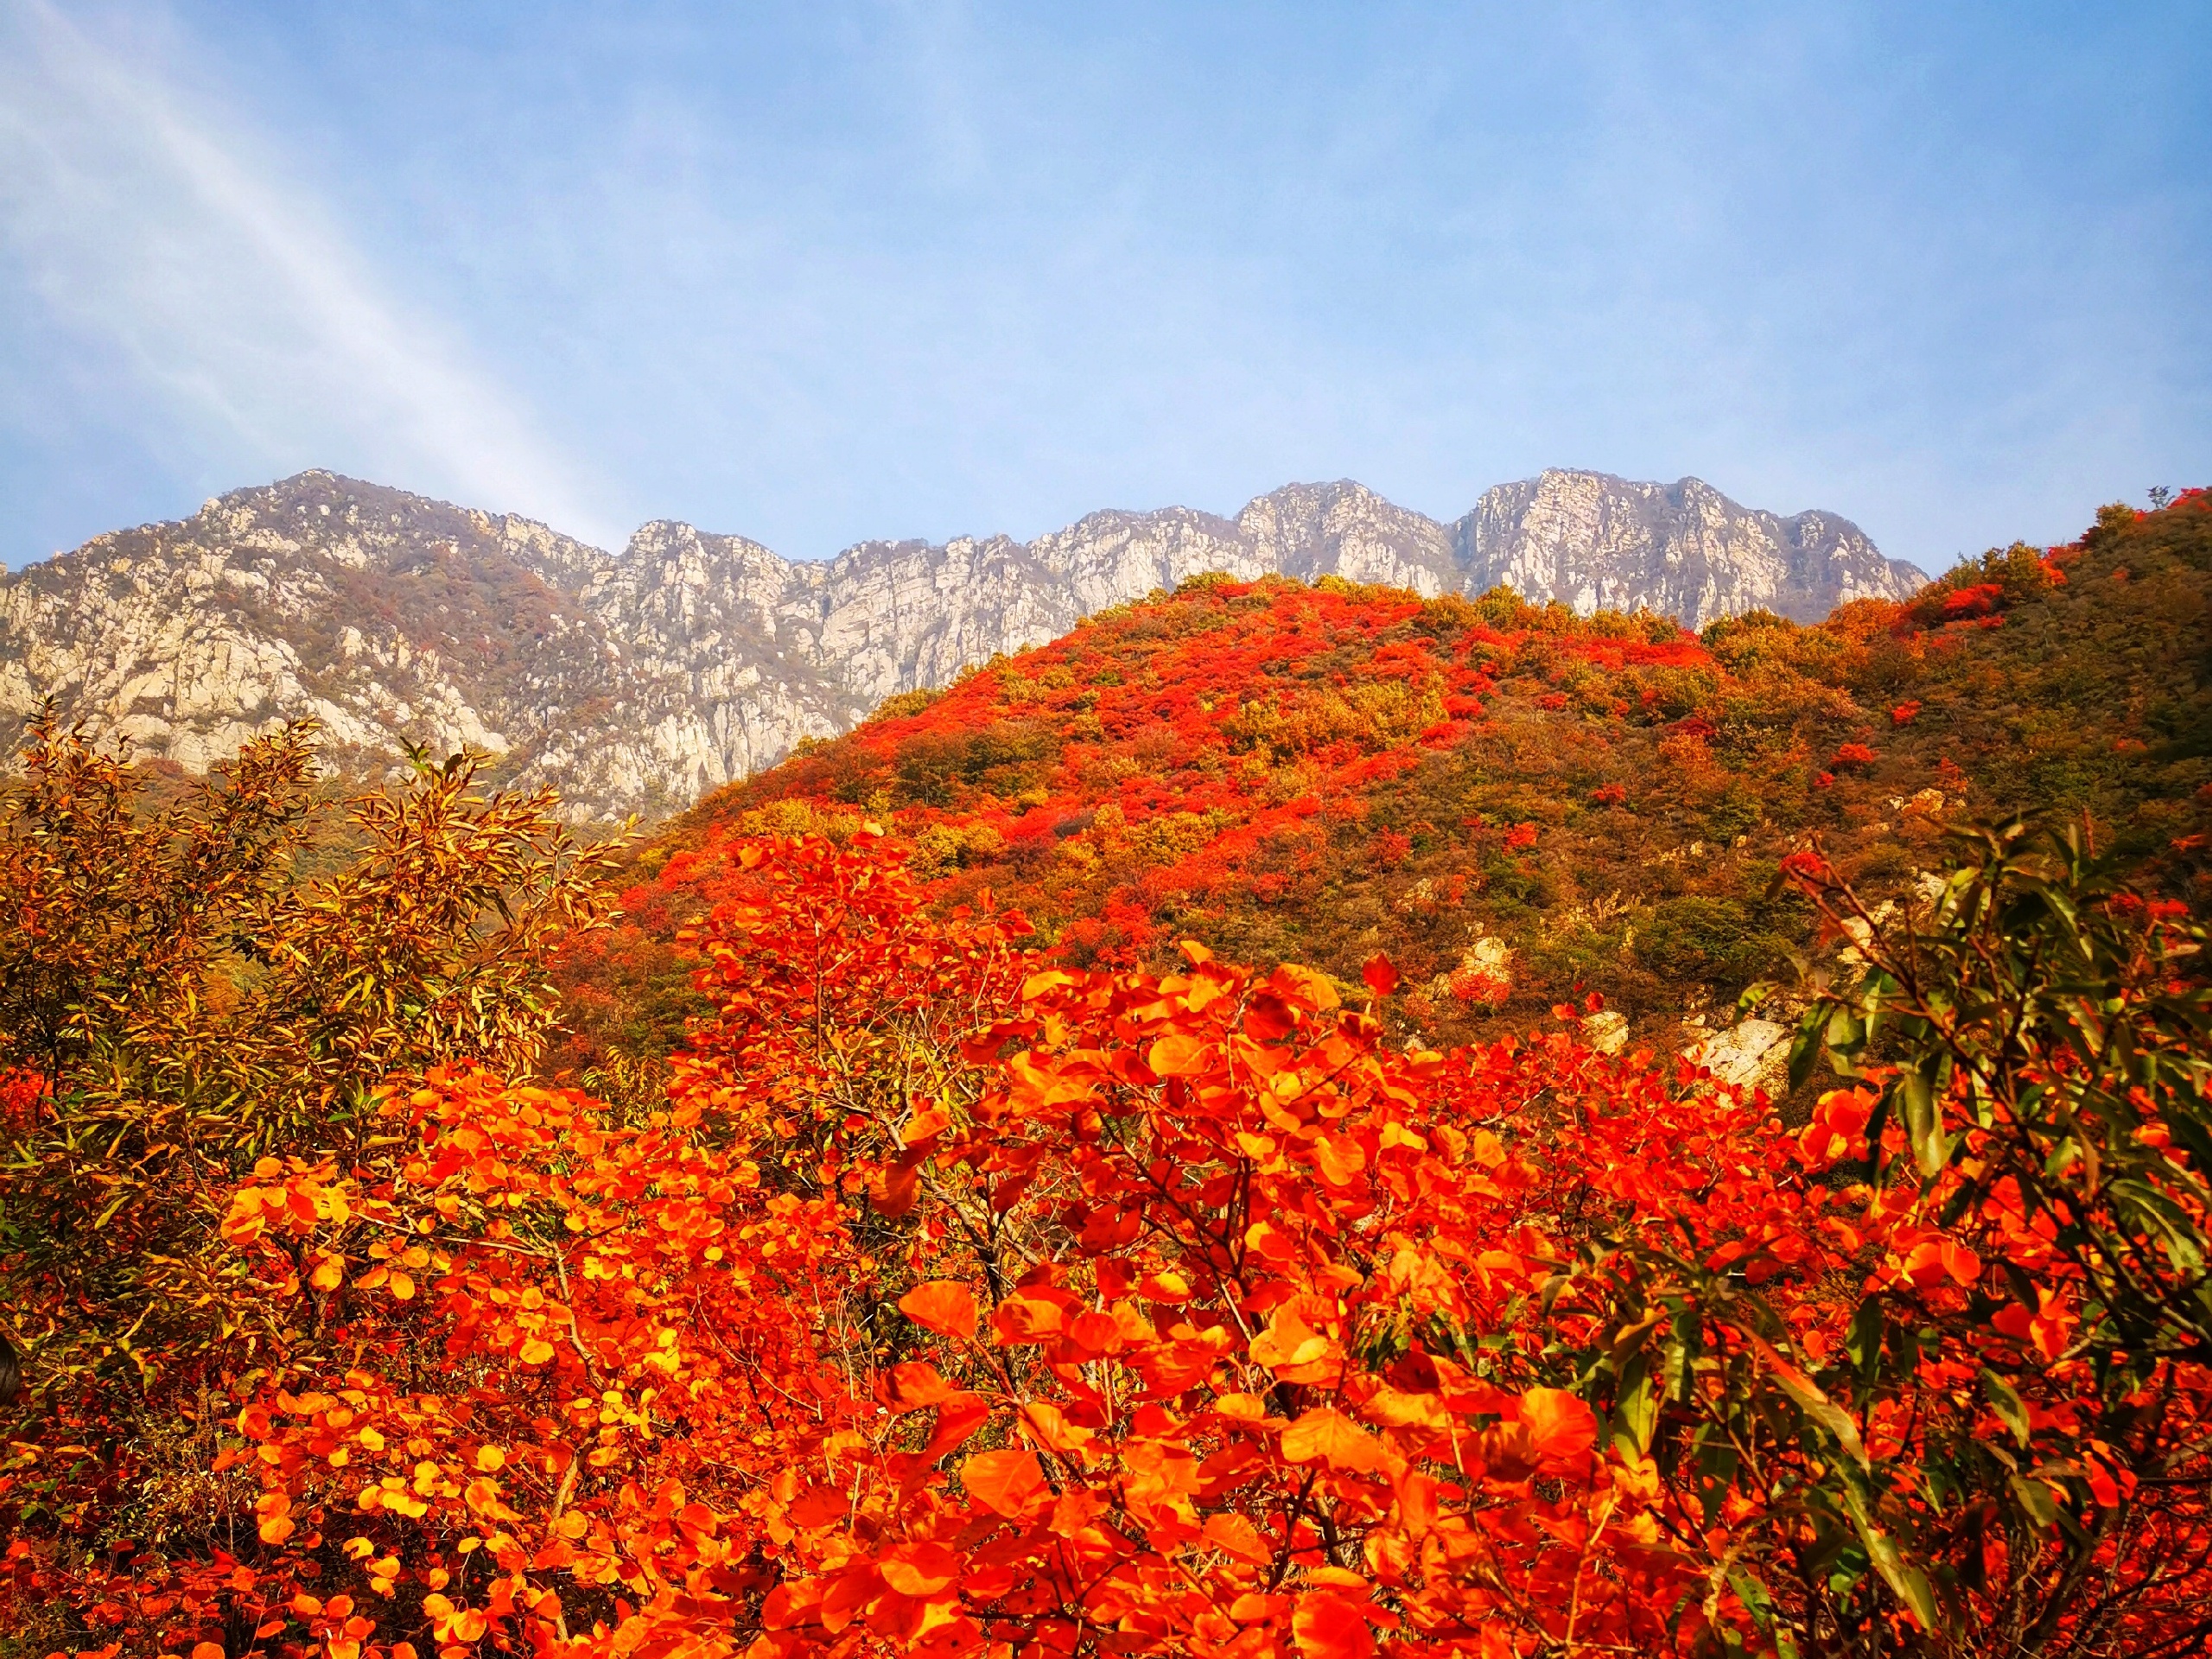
11;834;2212;1659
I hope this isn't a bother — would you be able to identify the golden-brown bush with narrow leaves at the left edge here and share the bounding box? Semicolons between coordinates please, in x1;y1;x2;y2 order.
0;712;606;1659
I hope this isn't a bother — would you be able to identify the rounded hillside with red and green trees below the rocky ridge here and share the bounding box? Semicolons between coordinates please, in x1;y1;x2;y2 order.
564;491;2212;1092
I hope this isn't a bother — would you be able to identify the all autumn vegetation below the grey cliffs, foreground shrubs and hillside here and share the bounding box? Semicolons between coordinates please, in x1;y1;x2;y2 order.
0;493;2212;1659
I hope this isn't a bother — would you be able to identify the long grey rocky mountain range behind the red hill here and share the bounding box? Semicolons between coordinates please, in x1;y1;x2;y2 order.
0;471;1920;818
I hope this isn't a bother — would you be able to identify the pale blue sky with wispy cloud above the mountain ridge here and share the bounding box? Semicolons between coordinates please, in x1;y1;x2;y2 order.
0;0;2212;569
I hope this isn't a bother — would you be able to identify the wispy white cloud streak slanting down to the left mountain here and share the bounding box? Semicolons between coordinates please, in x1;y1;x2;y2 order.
0;0;617;553
